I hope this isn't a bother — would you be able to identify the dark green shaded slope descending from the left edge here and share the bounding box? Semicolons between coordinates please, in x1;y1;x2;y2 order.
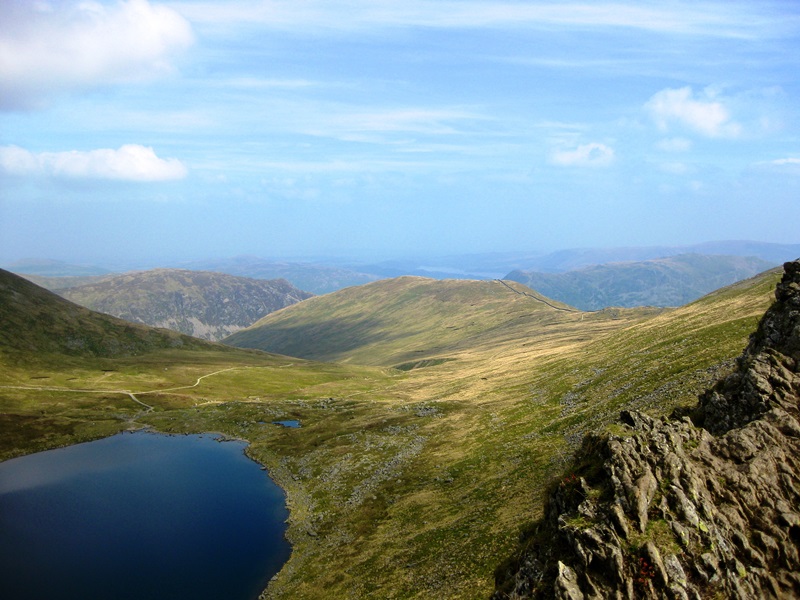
0;269;209;357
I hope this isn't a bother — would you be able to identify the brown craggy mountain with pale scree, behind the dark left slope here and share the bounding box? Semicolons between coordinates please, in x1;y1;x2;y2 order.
58;269;312;340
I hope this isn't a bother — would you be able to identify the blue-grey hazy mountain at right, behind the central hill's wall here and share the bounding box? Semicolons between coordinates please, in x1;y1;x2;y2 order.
506;254;773;310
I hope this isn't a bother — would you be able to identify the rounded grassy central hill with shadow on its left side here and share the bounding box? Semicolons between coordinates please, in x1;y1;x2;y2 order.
224;277;592;366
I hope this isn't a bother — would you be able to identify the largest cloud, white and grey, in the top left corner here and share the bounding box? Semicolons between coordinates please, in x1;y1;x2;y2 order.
0;0;193;109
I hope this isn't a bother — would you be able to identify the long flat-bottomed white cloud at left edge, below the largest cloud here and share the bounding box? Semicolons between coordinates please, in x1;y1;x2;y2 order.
0;144;187;181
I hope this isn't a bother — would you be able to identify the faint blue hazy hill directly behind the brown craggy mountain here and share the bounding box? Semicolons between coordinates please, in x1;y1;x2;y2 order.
183;256;380;294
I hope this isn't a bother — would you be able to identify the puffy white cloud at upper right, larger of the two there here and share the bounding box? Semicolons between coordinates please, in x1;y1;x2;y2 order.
645;87;742;138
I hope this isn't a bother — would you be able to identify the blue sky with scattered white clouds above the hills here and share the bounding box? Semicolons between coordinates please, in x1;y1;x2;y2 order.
0;0;800;264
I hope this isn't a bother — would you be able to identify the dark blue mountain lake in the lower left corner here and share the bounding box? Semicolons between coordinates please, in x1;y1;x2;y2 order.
0;432;290;600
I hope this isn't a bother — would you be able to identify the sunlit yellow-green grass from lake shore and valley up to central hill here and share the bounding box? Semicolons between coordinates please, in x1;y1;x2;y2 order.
0;274;777;598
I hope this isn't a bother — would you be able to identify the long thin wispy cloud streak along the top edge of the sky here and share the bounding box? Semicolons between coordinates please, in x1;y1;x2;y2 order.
174;0;780;38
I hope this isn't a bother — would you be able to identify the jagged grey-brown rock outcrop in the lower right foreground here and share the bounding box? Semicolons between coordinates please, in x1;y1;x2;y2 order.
493;262;800;600
